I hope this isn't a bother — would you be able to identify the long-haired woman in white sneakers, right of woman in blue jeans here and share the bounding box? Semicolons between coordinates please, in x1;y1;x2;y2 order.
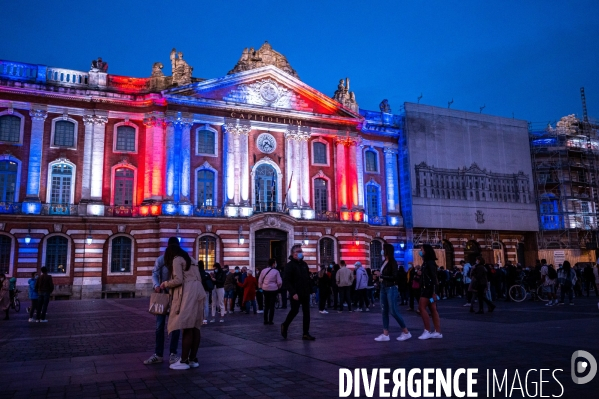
418;244;443;339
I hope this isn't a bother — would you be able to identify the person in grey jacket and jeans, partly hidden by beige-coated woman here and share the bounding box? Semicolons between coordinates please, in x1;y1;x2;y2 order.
144;237;180;364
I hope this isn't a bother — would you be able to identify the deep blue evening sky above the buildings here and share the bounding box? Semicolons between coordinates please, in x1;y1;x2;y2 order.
0;0;599;123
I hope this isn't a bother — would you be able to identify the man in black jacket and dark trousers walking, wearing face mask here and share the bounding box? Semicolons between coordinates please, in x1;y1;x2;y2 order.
281;244;316;341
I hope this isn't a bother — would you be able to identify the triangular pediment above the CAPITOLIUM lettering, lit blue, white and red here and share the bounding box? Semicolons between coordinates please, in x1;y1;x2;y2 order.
163;65;362;120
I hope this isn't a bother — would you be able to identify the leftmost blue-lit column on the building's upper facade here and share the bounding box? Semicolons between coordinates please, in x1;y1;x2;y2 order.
23;108;48;214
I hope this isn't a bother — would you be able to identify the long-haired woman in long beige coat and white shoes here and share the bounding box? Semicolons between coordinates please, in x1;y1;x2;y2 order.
160;241;206;370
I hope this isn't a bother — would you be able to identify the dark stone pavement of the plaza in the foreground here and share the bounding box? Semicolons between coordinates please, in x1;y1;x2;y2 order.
0;297;599;399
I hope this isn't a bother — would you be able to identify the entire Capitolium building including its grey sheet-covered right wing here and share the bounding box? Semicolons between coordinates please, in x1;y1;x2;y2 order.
0;43;538;298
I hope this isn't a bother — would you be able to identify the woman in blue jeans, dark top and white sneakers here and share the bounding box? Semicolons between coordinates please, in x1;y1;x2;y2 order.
374;244;412;342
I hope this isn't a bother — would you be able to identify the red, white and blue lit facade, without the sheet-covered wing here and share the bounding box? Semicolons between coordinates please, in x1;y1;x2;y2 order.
0;43;406;298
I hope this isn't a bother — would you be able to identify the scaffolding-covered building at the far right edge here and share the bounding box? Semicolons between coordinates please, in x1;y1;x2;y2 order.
529;111;599;250
